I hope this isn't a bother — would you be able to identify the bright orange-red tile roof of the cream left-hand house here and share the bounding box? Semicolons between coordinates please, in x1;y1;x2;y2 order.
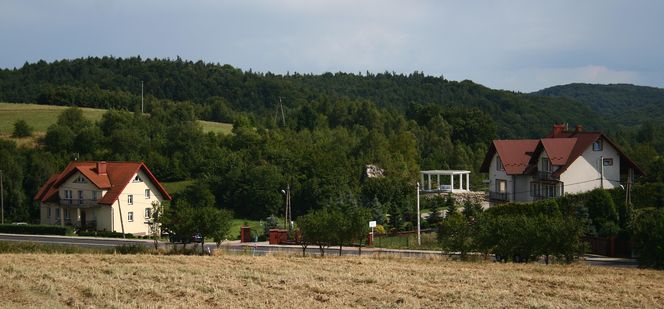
34;161;171;205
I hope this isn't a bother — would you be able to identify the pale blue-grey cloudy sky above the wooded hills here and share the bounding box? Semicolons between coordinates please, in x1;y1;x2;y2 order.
0;0;664;92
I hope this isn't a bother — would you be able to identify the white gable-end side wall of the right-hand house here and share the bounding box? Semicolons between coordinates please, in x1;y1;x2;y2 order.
560;141;620;193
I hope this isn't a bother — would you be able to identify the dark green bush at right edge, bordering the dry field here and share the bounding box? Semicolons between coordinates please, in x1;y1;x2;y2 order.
632;208;664;269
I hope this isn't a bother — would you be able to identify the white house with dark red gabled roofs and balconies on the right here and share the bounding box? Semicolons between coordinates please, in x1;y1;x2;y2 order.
480;125;643;202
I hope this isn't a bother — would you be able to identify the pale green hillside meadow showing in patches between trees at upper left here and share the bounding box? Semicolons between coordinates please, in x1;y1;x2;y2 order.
0;103;233;137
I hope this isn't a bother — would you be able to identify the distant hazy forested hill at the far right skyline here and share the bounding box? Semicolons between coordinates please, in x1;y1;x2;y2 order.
533;83;664;126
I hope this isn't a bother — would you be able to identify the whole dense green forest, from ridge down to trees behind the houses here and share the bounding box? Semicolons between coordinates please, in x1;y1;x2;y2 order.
0;57;664;228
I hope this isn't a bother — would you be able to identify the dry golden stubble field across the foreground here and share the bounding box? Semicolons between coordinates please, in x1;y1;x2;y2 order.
0;254;664;308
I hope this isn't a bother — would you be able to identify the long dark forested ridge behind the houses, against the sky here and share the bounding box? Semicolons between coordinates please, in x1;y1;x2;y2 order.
0;57;603;138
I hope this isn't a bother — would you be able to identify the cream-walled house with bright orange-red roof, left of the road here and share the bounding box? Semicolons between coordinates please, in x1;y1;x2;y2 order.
34;161;171;235
